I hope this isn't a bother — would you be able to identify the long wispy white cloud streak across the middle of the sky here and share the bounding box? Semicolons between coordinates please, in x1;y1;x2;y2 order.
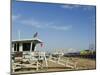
21;19;72;31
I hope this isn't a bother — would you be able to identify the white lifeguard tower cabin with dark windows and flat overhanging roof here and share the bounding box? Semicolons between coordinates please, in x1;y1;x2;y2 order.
12;38;42;52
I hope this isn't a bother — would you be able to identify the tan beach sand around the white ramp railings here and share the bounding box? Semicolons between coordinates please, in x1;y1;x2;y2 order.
12;57;96;74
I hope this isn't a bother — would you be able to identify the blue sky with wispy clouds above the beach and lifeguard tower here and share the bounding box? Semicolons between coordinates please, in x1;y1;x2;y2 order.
12;1;96;51
